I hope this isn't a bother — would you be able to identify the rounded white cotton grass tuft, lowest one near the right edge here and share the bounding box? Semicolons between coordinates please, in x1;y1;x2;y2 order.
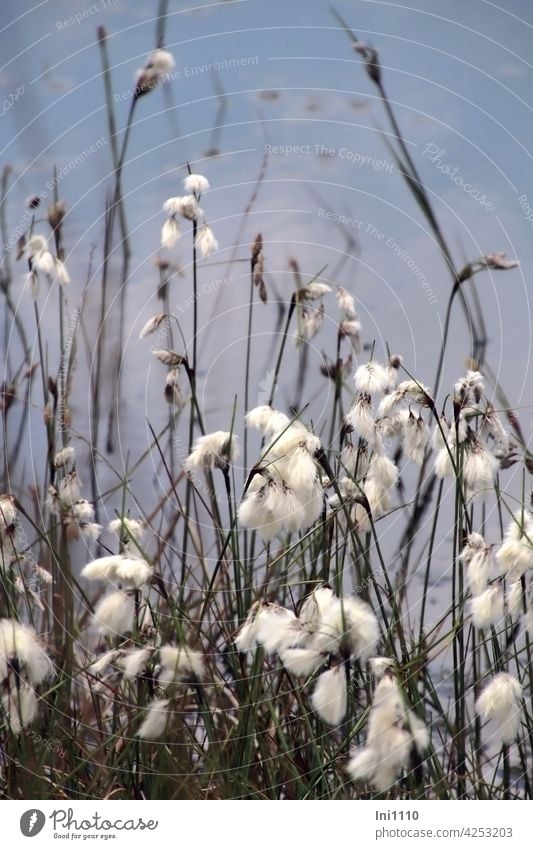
476;672;522;743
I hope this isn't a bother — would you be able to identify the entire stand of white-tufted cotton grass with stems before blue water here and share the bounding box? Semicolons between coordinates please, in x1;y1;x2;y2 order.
0;9;533;800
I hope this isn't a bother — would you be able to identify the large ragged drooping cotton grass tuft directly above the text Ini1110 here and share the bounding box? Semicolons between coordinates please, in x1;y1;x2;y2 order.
347;674;429;793
